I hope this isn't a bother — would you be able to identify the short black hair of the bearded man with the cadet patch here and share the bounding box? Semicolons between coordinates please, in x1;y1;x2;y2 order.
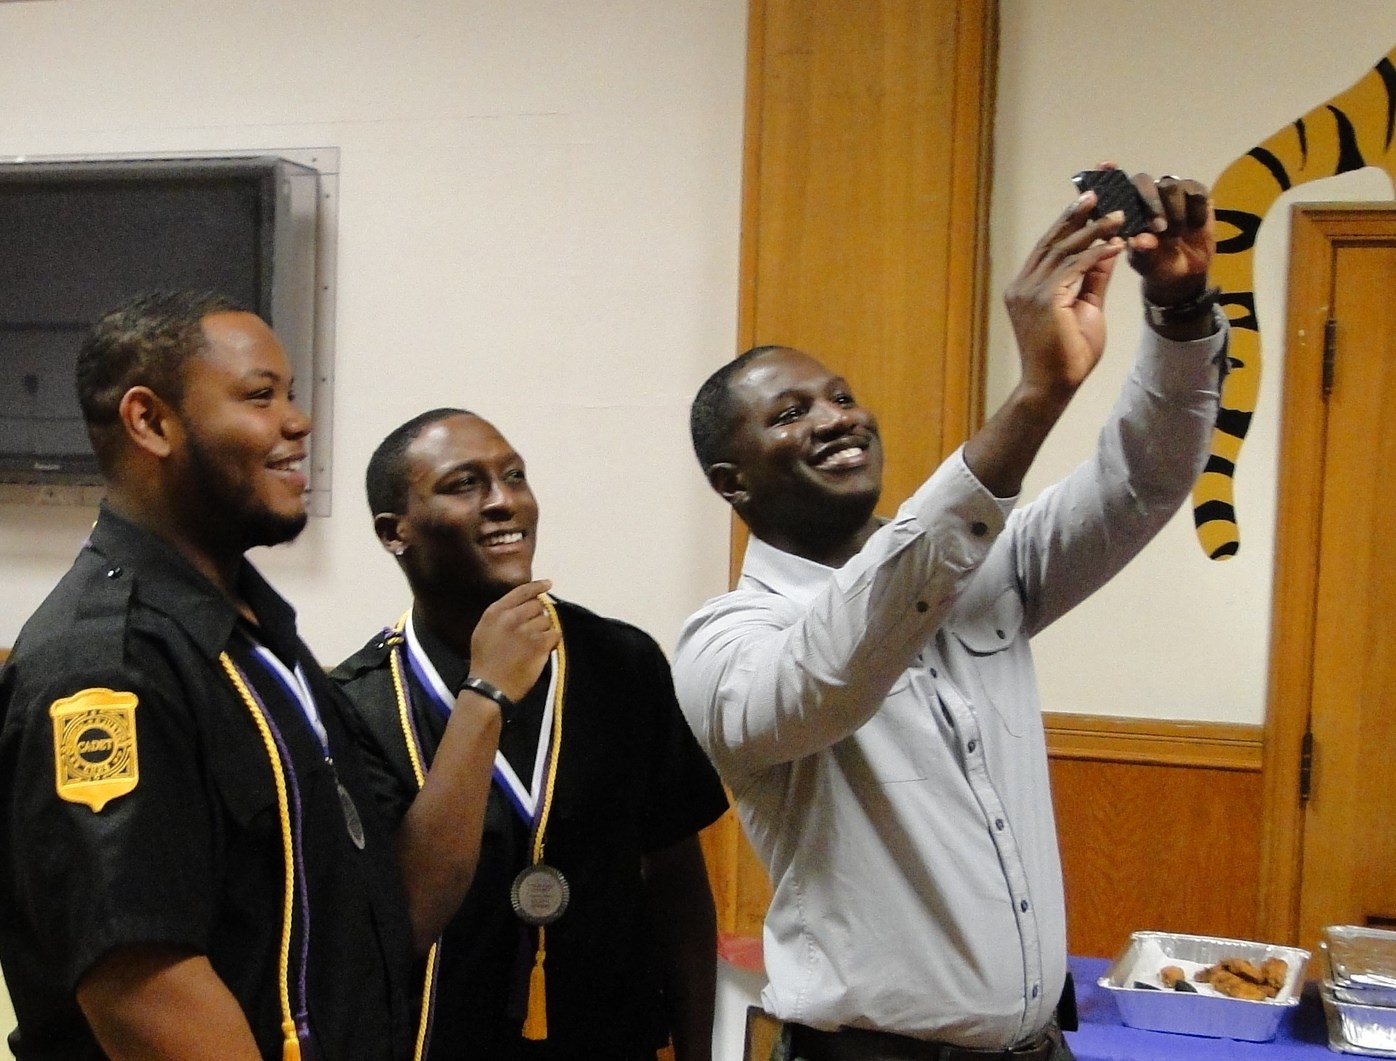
75;290;247;463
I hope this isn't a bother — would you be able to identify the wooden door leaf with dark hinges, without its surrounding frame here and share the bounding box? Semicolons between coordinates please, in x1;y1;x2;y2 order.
1300;237;1396;940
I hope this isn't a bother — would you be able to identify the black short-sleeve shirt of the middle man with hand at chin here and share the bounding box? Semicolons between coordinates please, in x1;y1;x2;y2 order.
331;600;727;1061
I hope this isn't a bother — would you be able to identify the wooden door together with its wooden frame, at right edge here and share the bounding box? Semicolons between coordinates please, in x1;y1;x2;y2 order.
1270;205;1396;948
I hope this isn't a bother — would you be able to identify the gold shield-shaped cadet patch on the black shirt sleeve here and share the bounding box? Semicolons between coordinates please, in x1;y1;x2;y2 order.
49;688;141;811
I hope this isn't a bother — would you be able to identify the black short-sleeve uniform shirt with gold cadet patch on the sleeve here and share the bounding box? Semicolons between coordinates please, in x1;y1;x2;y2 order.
0;510;413;1058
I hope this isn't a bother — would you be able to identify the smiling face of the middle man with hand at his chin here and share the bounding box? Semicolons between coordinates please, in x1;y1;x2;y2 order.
388;415;537;602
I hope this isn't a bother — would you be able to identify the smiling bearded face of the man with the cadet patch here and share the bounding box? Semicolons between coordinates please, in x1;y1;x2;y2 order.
177;313;310;551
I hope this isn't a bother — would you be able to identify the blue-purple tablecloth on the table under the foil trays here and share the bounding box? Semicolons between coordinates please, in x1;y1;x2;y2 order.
1067;958;1342;1061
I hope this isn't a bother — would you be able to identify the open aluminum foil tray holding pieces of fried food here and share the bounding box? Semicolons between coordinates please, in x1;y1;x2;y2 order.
1097;933;1309;1043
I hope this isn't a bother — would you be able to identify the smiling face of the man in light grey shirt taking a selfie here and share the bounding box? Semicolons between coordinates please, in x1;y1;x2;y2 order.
709;348;882;561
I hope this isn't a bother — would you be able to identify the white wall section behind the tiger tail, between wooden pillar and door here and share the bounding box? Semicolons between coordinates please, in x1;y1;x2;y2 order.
988;0;1396;723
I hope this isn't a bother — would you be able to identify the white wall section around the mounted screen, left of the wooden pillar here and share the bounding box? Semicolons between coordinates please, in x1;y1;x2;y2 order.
0;0;745;663
